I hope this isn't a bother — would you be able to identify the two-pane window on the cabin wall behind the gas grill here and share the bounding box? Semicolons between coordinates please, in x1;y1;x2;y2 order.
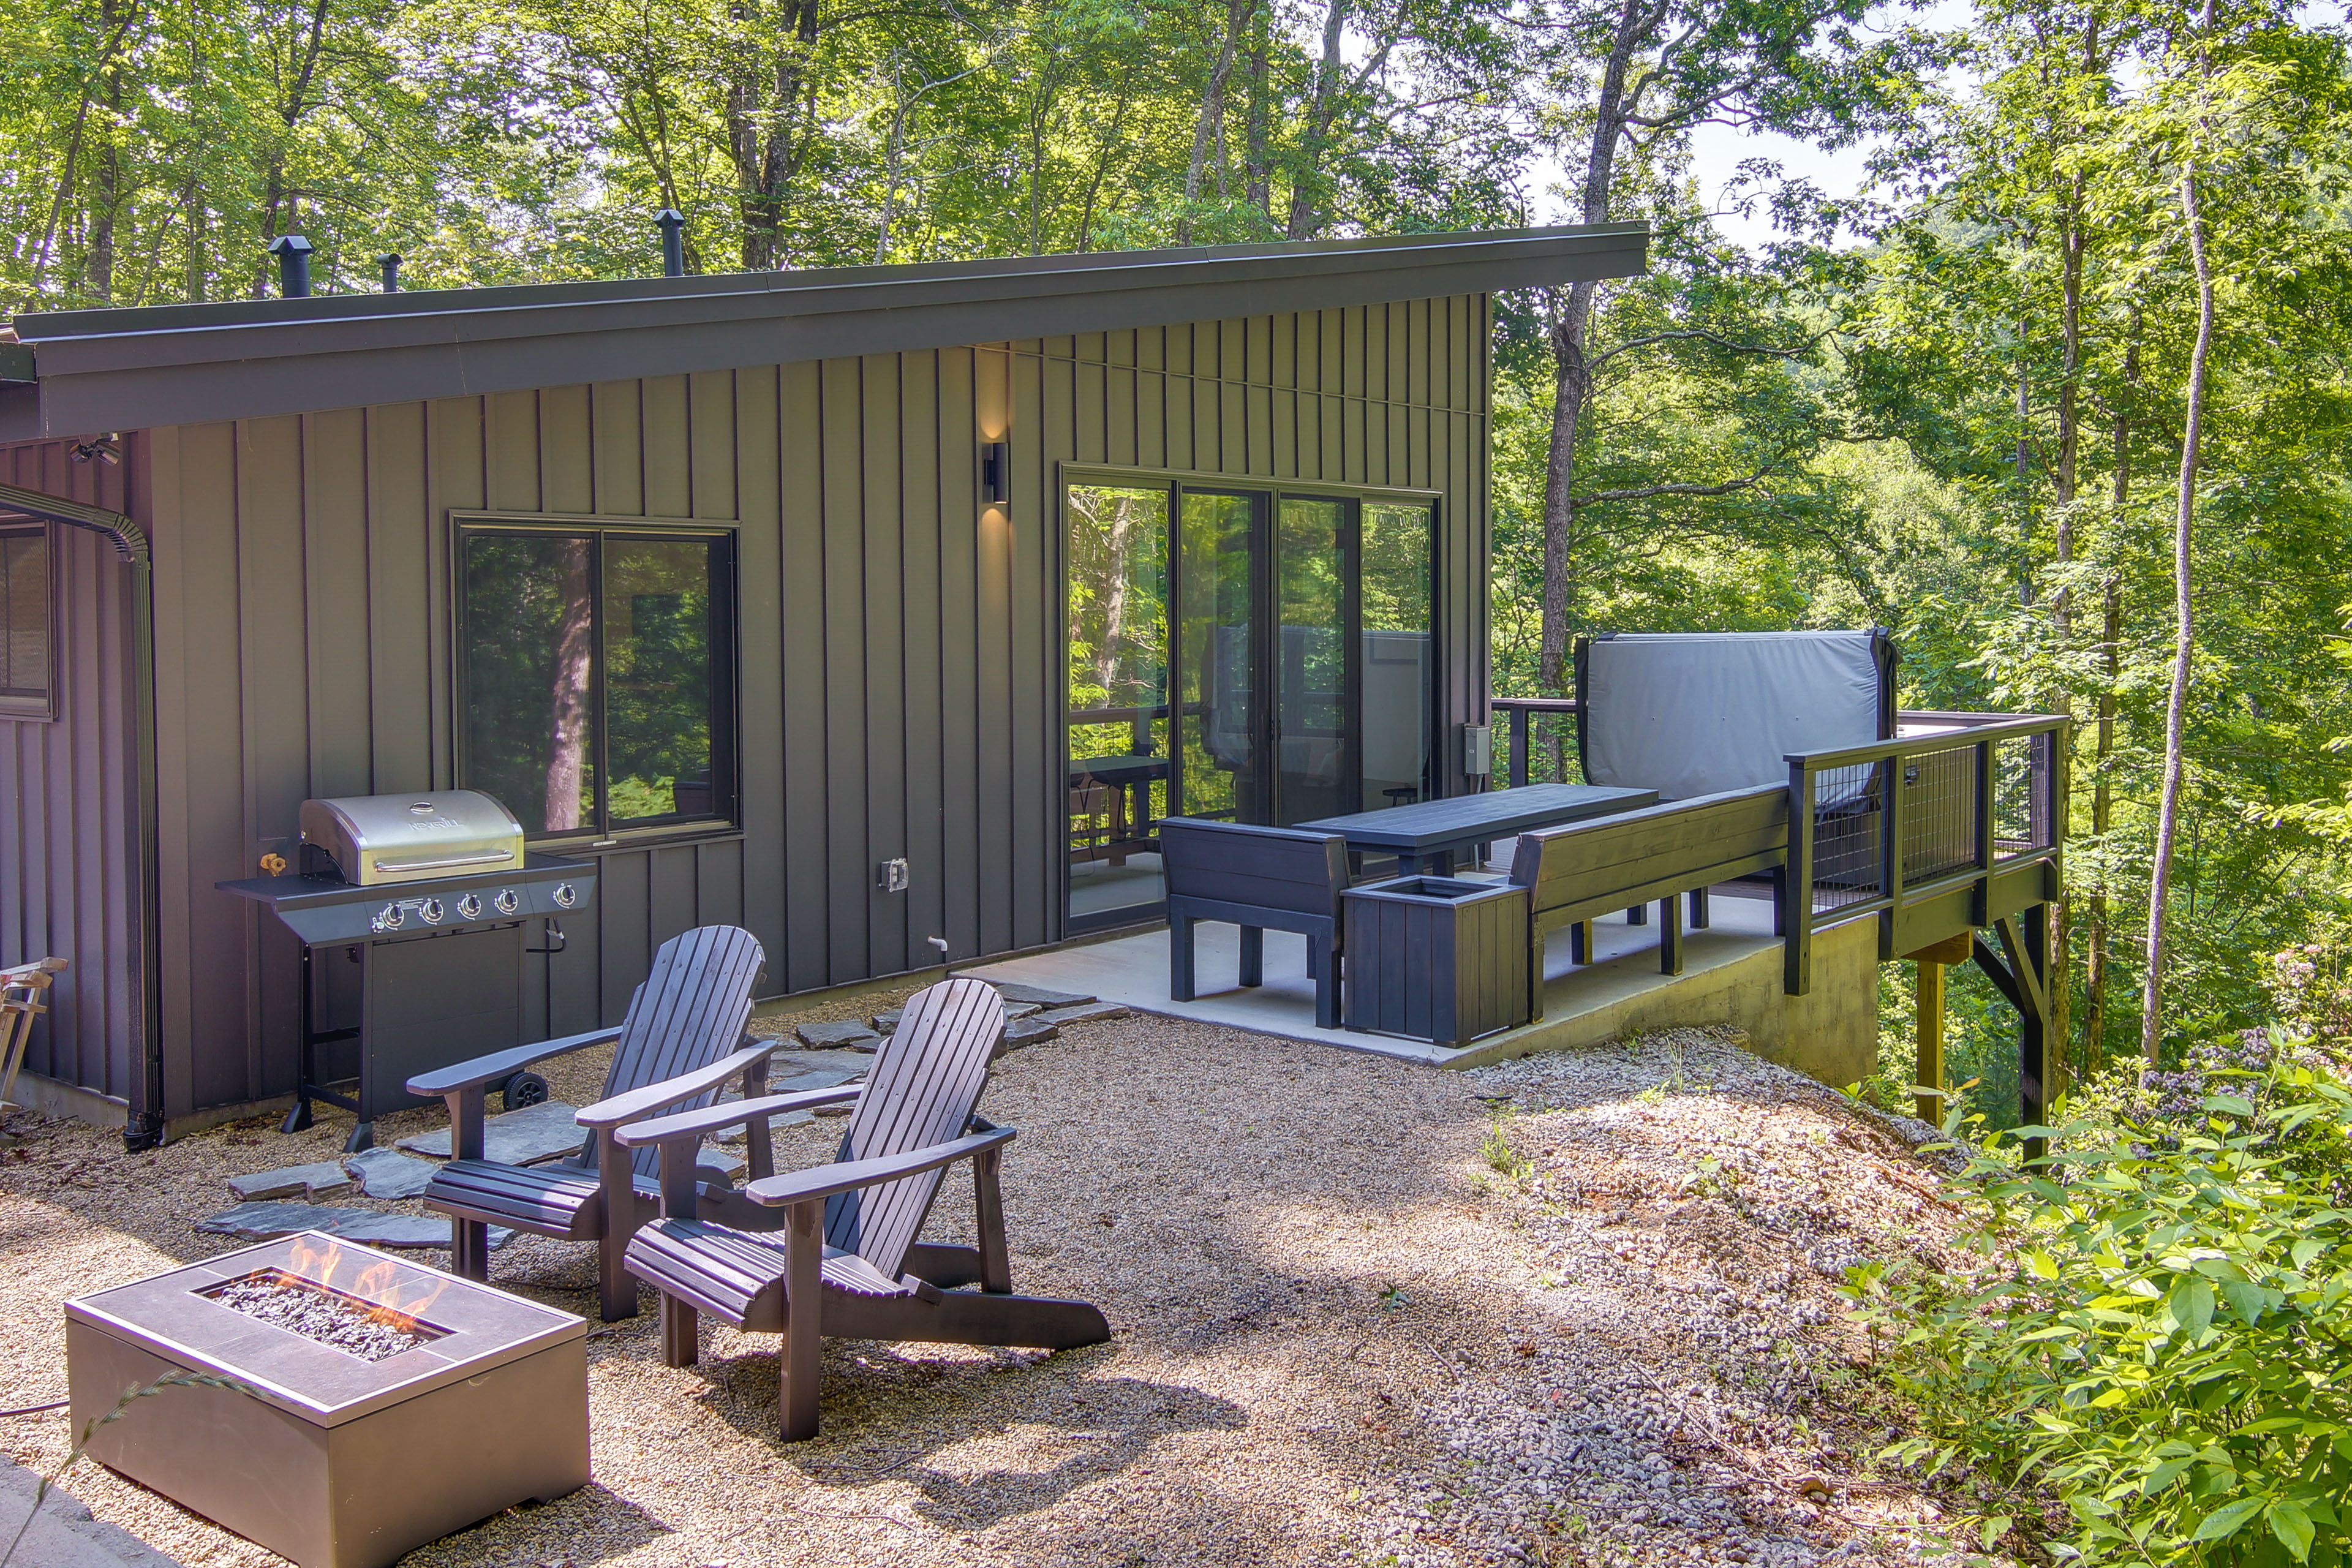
456;522;736;839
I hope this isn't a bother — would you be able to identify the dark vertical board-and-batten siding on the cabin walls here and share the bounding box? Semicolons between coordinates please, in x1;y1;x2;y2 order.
0;298;1489;1114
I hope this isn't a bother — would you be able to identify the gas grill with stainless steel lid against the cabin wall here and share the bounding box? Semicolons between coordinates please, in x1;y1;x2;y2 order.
216;790;597;1152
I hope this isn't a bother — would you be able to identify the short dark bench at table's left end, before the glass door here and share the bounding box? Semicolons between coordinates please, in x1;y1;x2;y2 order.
1159;816;1348;1030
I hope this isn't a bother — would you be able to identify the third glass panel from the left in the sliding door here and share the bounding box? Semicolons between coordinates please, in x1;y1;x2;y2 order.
1272;496;1355;823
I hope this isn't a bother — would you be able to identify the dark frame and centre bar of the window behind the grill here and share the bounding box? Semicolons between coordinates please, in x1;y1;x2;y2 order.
449;513;743;851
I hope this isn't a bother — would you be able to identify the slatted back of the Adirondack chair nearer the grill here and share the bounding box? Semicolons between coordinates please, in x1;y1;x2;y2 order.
581;926;767;1180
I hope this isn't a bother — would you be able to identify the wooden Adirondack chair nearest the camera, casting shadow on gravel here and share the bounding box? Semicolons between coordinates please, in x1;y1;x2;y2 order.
614;980;1110;1444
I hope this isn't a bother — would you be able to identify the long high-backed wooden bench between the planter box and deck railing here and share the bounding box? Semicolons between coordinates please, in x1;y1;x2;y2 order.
1510;785;1787;1018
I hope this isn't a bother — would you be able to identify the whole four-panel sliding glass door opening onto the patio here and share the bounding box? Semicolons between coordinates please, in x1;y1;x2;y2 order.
1066;480;1437;931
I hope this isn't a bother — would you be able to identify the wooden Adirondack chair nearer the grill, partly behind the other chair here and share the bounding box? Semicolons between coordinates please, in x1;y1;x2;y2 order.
409;926;776;1324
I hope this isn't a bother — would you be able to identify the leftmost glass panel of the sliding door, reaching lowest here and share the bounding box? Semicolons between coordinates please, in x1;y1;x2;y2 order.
1068;484;1174;919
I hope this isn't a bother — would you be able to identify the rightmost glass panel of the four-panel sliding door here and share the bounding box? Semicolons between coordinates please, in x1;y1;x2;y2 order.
1357;501;1437;811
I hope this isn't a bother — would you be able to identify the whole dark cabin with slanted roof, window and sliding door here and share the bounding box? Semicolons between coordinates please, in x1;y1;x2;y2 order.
0;225;1646;1142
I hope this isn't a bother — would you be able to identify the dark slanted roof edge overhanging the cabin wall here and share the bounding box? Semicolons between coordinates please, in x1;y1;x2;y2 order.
0;224;1649;440
